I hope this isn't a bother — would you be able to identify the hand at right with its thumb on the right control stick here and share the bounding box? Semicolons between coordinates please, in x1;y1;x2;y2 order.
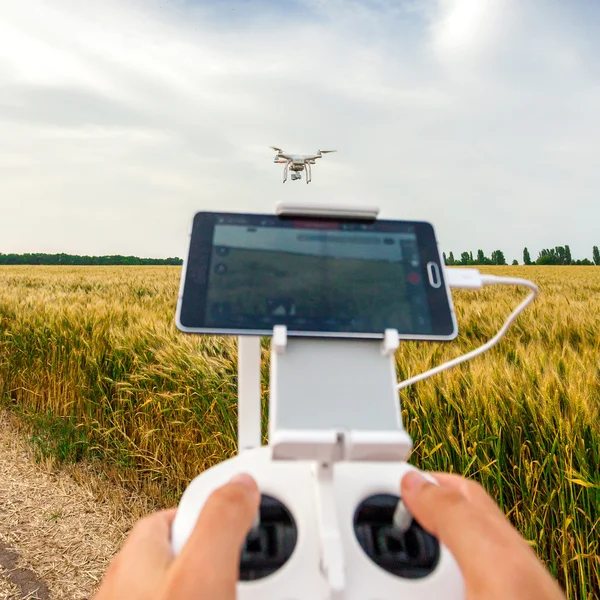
401;471;565;600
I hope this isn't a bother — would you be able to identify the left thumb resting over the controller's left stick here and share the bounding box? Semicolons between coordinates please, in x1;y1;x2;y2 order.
164;475;260;600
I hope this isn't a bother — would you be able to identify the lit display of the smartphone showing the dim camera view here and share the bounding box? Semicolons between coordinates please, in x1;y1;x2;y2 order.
205;218;431;334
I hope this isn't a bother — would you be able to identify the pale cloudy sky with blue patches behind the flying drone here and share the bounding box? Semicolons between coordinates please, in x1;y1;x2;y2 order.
0;0;600;262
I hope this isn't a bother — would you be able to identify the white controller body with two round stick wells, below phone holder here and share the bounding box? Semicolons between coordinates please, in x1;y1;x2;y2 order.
172;446;465;600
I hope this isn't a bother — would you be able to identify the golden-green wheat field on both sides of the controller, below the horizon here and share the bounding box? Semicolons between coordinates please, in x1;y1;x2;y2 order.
0;266;600;599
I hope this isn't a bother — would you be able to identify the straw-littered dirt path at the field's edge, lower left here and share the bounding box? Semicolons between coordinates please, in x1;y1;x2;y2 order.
0;412;155;600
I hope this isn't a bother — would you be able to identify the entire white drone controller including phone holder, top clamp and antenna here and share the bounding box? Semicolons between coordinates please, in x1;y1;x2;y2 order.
171;203;465;600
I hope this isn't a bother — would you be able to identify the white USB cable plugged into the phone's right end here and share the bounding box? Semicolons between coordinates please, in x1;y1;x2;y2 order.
397;268;540;390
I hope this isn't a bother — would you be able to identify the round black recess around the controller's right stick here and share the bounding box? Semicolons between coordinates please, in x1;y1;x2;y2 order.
354;494;440;579
